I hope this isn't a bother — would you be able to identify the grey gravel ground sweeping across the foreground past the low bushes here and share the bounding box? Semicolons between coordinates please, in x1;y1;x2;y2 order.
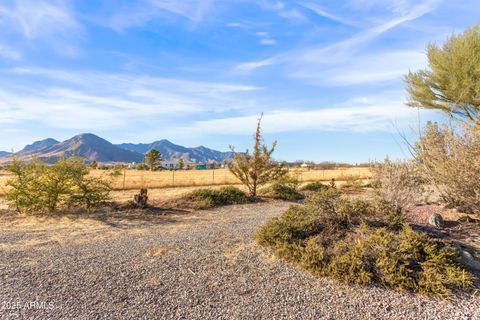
0;202;480;319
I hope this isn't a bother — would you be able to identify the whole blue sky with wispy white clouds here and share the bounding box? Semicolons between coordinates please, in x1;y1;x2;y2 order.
0;0;480;162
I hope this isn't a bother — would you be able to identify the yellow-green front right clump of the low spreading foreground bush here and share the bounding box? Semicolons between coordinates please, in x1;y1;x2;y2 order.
319;226;474;297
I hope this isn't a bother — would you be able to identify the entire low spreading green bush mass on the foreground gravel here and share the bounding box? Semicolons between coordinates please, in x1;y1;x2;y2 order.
255;189;474;297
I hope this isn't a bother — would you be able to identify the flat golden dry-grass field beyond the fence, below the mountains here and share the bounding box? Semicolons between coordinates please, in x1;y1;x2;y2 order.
0;167;371;195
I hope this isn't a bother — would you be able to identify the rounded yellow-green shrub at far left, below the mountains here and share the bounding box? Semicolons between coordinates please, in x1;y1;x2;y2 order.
6;157;111;212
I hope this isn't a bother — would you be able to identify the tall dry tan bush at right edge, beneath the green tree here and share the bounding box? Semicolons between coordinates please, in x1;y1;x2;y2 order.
415;123;480;213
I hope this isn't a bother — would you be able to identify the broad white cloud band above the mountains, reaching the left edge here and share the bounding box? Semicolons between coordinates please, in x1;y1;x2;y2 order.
0;68;260;130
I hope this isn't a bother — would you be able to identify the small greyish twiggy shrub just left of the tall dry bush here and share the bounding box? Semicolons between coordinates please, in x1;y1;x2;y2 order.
371;158;425;214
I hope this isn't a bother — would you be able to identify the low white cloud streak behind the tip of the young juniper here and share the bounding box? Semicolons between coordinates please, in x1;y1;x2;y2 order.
161;93;428;135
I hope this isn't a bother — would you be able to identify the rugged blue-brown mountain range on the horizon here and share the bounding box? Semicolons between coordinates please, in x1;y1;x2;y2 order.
0;133;233;163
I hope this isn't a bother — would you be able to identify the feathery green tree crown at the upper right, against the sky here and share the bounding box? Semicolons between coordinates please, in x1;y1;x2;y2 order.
405;25;480;125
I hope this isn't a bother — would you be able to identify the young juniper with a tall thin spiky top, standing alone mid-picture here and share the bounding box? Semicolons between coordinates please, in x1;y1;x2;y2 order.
227;114;287;198
